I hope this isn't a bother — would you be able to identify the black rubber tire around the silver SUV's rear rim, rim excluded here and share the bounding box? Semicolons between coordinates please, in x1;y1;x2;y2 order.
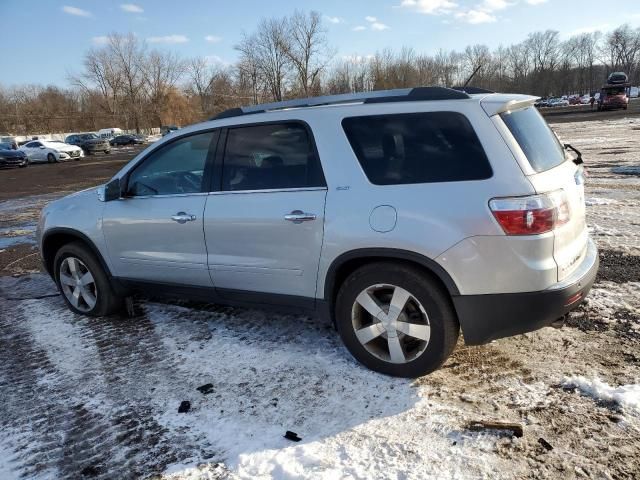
335;262;460;378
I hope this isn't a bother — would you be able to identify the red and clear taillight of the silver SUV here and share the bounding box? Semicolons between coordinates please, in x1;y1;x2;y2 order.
489;190;571;235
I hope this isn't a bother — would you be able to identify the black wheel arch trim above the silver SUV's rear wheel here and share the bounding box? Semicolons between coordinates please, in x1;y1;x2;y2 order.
323;248;460;302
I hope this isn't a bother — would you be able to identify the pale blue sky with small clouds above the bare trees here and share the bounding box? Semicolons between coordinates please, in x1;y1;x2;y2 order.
0;0;640;86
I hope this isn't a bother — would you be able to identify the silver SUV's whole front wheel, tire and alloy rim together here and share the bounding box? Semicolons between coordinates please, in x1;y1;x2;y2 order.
54;242;123;317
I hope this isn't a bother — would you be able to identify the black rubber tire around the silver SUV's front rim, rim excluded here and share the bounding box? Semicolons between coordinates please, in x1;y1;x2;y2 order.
53;242;124;317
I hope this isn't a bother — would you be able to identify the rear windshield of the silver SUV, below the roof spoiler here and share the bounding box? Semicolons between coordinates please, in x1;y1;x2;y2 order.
500;107;565;172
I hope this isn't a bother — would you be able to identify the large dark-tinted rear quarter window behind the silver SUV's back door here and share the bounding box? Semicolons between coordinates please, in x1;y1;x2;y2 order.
342;112;492;185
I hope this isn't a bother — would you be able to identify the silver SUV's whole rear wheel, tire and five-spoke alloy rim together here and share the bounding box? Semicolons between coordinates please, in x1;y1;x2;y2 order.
336;263;460;378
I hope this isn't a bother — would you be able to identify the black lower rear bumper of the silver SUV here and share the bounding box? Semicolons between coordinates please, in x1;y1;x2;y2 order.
453;239;599;345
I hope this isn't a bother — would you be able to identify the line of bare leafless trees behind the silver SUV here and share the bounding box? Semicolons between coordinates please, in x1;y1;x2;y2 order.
0;11;640;135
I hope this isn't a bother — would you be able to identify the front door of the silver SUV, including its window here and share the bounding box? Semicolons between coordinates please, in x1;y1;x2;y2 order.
103;131;219;287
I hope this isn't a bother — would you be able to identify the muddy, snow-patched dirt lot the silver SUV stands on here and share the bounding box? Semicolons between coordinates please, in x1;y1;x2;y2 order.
0;116;640;479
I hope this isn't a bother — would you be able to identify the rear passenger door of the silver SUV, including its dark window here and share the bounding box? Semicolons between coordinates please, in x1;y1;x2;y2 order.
204;122;327;302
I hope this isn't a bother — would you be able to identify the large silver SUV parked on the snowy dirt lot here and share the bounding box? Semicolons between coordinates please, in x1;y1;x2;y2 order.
38;87;598;377
